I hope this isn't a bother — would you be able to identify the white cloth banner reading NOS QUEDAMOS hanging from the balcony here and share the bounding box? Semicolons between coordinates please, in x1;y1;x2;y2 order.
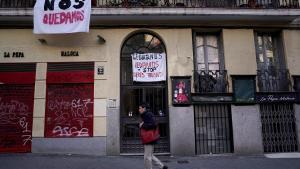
33;0;91;34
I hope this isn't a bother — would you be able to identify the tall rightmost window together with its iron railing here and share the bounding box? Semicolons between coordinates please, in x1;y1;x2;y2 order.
255;32;290;92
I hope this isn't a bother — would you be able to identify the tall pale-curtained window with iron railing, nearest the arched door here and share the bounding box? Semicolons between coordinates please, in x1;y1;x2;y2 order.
194;33;228;93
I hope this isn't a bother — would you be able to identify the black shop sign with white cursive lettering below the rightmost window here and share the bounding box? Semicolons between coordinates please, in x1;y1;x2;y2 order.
256;92;297;103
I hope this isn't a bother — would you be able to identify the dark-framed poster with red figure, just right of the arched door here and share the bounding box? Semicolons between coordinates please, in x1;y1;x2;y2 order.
171;76;191;105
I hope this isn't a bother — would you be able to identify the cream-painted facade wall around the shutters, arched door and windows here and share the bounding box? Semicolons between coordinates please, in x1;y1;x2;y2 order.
0;28;300;154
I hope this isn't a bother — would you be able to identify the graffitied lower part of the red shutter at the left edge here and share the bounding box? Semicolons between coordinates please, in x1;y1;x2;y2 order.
0;84;34;152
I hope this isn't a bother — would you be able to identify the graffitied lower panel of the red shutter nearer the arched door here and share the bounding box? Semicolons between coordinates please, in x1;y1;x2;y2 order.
45;84;94;137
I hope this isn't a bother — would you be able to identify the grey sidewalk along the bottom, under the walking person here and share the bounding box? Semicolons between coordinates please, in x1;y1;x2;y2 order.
0;154;300;169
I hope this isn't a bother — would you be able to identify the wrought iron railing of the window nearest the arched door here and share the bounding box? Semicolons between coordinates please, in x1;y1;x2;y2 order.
194;70;228;93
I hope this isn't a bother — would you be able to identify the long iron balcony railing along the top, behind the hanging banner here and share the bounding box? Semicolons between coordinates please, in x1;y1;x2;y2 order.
0;0;300;9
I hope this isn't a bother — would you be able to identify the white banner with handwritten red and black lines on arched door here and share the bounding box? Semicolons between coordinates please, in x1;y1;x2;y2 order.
131;53;166;82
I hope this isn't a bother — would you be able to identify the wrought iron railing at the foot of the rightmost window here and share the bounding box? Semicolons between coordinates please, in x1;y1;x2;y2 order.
257;69;291;92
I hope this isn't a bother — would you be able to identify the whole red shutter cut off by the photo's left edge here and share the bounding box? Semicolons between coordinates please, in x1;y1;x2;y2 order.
0;63;35;152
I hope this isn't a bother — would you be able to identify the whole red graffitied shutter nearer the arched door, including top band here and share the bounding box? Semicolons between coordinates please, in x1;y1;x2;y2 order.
45;63;94;137
